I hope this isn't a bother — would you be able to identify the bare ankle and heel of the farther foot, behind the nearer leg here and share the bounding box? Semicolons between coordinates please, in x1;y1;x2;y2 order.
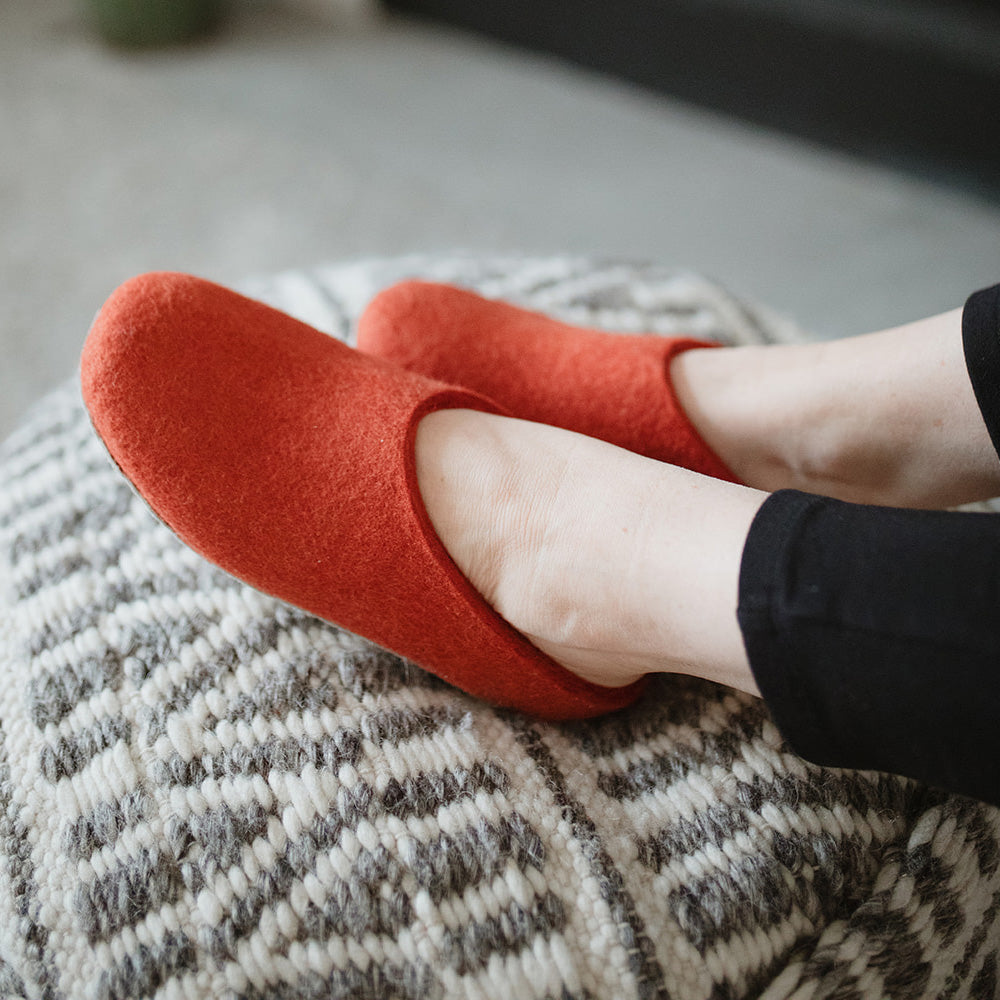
671;310;1000;508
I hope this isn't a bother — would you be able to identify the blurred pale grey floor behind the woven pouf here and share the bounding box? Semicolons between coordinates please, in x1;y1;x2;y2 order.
0;0;1000;437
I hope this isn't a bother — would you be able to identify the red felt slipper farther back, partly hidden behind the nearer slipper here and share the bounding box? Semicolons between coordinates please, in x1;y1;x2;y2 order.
358;281;736;481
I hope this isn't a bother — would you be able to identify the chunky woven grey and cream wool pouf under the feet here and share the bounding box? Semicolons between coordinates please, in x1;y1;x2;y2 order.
0;257;1000;1000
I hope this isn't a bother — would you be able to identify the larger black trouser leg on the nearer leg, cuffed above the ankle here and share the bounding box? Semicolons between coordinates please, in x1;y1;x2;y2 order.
738;490;1000;805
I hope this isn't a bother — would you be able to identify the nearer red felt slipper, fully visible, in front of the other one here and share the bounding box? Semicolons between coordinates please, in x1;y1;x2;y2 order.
82;274;642;718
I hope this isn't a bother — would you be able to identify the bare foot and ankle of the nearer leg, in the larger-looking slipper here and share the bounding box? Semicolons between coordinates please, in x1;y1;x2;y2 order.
416;406;764;693
